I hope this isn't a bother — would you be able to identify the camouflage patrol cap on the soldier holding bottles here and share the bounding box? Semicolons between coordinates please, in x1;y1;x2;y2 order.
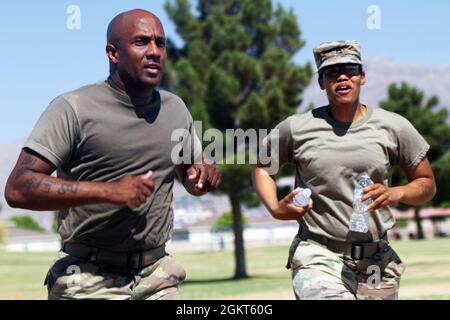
313;40;362;70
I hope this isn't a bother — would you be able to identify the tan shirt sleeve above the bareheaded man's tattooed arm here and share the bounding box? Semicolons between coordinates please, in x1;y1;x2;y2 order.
24;97;79;167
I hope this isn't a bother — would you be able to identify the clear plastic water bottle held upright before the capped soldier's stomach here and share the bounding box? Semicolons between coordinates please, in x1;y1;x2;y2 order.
349;173;373;233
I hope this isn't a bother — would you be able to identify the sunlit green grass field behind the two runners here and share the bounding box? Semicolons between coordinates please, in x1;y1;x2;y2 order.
0;239;450;300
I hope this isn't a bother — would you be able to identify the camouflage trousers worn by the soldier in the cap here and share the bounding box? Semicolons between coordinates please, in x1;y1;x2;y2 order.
291;240;405;300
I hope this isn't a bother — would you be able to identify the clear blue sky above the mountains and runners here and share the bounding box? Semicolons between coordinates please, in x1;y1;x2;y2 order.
0;0;450;143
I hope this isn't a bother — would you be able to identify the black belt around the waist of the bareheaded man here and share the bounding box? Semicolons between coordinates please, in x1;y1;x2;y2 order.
62;243;167;269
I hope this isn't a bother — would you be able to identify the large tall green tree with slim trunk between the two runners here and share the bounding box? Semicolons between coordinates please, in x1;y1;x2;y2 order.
162;0;312;278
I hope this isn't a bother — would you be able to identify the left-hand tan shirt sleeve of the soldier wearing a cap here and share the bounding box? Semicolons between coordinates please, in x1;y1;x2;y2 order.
258;118;293;175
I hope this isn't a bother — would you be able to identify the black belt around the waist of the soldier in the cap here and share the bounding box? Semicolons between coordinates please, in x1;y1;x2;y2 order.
300;228;387;260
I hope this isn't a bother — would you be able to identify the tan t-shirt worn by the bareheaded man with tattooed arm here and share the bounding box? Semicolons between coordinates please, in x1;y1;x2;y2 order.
24;82;202;251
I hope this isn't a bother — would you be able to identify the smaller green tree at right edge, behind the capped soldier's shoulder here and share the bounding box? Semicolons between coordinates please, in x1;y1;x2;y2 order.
380;82;450;239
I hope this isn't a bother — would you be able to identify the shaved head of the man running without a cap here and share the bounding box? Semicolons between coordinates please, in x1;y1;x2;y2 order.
106;9;167;92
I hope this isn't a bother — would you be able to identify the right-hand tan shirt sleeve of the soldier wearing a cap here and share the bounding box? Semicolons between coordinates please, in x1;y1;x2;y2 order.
396;117;430;168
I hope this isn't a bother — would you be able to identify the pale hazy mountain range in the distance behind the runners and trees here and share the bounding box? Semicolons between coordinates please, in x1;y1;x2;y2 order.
0;57;450;230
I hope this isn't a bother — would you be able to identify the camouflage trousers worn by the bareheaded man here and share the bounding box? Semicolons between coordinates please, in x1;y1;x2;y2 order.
45;252;186;300
